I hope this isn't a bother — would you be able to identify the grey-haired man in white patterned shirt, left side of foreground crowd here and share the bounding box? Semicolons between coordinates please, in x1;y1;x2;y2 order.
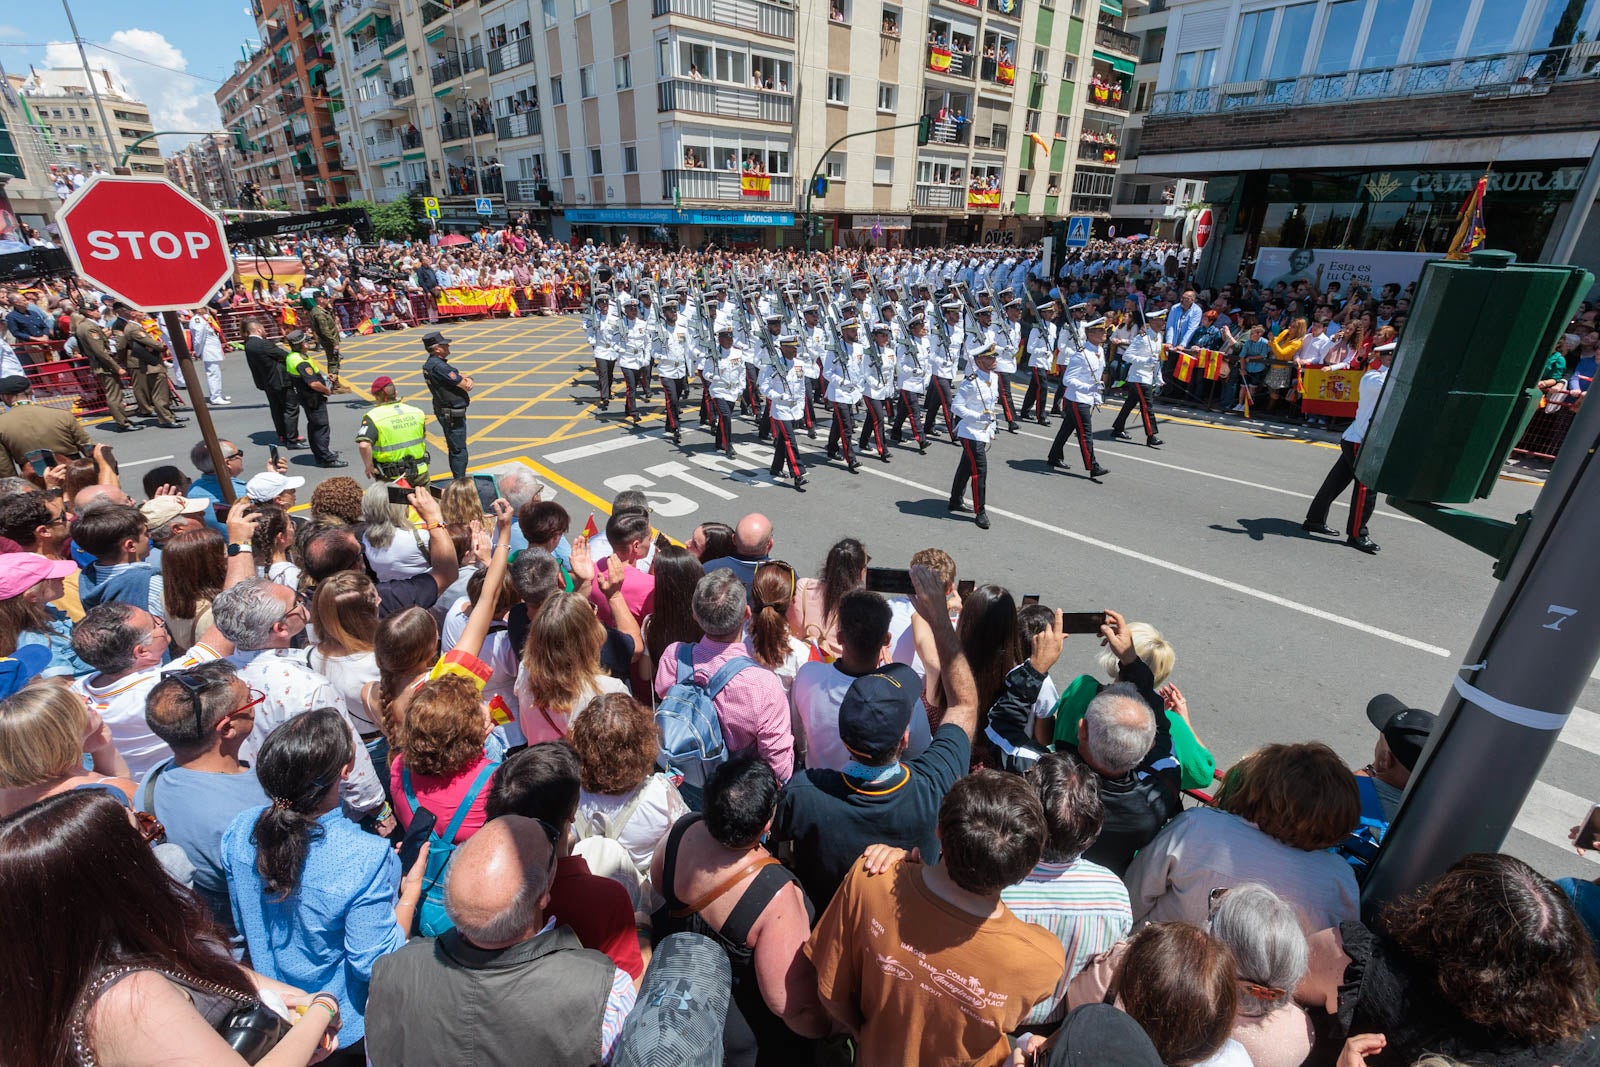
211;577;394;833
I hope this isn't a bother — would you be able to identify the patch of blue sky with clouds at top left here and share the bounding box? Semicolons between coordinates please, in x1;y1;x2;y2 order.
0;0;258;149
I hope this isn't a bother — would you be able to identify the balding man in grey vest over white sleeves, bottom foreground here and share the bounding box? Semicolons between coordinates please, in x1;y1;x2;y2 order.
366;814;635;1064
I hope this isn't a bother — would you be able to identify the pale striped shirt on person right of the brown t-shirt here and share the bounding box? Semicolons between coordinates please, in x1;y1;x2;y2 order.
1000;859;1133;1025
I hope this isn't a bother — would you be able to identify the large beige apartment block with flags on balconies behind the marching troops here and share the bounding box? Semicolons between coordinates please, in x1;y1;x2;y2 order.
330;0;1142;246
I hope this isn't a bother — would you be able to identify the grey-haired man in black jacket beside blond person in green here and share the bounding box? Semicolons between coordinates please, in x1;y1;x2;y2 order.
1074;681;1182;875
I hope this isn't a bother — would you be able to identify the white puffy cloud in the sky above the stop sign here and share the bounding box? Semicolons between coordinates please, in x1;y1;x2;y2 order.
43;29;221;152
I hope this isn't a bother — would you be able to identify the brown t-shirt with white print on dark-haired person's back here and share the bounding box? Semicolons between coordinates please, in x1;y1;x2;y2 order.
805;861;1067;1067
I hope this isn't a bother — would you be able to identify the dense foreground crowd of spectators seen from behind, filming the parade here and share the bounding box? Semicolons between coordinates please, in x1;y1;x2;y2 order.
0;428;1600;1067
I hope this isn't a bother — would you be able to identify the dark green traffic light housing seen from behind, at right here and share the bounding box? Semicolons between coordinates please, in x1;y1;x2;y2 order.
1355;251;1594;504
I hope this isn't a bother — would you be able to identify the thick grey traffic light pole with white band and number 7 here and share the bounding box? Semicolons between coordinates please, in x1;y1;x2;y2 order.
1362;395;1600;918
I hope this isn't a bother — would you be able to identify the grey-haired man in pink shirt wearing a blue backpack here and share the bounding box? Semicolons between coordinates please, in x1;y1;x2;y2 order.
656;571;795;781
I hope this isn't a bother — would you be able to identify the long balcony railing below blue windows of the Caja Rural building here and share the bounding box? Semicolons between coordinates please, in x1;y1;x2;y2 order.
1150;42;1600;115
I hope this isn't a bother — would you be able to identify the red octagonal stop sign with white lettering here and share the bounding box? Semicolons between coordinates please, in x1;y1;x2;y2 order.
56;174;234;312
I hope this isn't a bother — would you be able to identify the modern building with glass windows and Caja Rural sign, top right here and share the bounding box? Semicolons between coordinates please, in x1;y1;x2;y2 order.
1134;0;1600;282
